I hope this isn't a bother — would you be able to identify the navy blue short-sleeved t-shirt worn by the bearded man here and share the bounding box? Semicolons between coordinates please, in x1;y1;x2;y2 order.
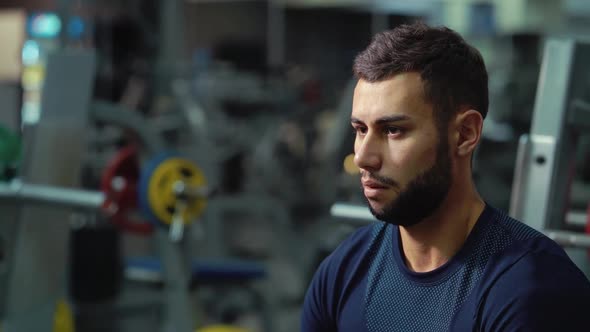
301;206;590;332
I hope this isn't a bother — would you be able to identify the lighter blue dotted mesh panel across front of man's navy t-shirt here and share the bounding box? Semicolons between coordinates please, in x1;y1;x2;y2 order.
365;210;541;332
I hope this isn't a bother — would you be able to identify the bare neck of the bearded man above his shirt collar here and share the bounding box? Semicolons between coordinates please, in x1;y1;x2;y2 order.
400;184;485;272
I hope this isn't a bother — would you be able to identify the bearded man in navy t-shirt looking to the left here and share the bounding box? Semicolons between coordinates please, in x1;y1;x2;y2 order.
302;23;590;332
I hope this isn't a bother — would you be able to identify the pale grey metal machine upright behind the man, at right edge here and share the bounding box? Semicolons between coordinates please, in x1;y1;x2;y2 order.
510;39;590;269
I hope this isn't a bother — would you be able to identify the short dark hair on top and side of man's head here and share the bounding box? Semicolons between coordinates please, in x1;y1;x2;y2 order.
353;22;488;125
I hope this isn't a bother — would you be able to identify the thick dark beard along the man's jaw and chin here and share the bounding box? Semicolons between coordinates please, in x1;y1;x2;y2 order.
367;135;451;227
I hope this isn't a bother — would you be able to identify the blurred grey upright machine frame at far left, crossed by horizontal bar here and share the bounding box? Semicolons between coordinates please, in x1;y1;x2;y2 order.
0;52;97;331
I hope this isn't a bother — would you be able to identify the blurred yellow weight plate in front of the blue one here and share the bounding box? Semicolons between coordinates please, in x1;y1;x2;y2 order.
148;158;207;225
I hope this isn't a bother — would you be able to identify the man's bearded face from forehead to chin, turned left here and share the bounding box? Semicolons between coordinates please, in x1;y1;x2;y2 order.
351;73;452;226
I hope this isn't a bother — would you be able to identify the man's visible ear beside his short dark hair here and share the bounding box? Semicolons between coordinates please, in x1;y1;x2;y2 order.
455;109;483;157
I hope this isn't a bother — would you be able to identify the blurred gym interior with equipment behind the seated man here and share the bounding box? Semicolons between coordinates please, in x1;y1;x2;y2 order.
0;0;590;332
